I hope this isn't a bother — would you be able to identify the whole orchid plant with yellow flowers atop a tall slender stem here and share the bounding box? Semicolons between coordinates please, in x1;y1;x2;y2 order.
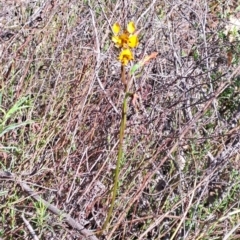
101;22;157;232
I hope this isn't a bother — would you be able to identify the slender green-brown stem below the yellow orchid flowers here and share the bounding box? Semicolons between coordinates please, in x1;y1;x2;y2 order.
102;65;129;231
